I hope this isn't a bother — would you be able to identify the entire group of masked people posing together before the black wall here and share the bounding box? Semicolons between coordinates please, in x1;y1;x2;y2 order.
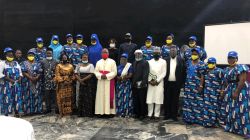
0;33;250;138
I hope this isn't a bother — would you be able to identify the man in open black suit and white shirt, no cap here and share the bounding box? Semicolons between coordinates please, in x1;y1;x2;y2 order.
164;46;185;121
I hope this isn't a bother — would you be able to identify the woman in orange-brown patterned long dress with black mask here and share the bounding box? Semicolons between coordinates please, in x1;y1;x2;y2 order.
55;54;74;117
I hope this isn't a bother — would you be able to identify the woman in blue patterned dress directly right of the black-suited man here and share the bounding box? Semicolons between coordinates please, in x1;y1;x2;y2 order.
183;48;205;125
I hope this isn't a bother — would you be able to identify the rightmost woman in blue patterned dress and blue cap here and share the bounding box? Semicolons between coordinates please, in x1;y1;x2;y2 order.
222;51;250;138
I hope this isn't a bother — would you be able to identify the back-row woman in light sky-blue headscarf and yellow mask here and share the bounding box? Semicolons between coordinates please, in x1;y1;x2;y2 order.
49;35;63;61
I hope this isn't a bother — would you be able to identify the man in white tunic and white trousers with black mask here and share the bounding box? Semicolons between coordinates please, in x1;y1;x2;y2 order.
147;47;167;120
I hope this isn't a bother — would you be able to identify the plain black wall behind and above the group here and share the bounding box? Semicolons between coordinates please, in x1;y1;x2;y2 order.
0;0;250;54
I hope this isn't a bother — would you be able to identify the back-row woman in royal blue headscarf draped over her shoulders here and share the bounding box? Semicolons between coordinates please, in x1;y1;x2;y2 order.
88;34;102;66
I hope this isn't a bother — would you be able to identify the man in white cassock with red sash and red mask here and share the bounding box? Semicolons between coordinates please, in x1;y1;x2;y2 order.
95;49;117;115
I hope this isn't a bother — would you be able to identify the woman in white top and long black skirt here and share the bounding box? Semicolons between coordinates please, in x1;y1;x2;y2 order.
75;53;96;117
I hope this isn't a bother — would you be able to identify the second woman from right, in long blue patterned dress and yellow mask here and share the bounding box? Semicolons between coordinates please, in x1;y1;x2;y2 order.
203;57;223;127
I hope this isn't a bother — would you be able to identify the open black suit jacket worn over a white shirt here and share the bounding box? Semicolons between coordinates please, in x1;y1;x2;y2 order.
165;55;186;88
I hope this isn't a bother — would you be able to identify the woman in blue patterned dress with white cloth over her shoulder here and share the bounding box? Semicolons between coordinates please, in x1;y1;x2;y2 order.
116;53;133;117
